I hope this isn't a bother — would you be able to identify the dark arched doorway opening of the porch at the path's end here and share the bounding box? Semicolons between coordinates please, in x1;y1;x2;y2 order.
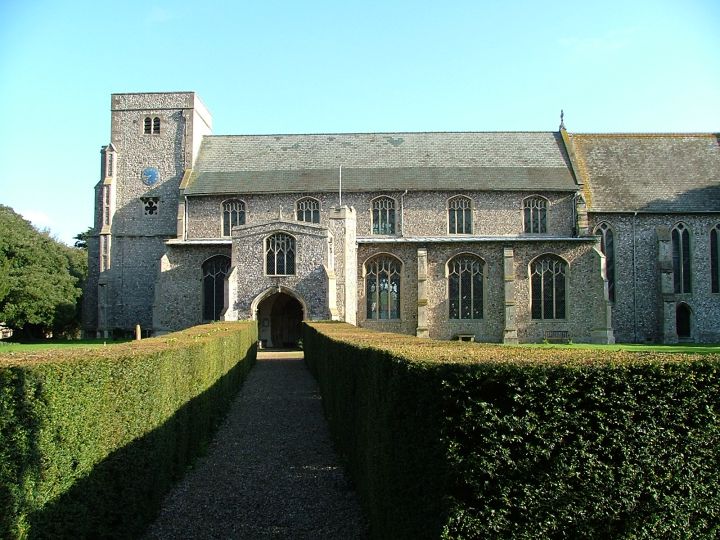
257;292;303;349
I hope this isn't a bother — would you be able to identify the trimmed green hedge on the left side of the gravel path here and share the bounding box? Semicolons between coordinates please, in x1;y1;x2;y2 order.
0;323;257;538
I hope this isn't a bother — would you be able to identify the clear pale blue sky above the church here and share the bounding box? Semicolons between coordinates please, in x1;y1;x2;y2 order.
0;0;720;243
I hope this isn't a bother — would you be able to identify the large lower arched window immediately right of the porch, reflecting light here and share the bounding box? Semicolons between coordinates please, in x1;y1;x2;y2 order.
365;255;401;319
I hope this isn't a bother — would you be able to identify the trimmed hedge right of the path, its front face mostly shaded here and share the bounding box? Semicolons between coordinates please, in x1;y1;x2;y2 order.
303;324;720;539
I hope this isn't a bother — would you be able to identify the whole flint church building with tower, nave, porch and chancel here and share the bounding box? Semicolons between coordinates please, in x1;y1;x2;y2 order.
84;92;720;347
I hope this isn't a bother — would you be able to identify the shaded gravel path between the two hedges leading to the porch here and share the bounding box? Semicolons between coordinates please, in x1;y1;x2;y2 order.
146;352;366;539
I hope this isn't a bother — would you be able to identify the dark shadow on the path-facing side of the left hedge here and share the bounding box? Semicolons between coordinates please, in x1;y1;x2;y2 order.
28;351;254;539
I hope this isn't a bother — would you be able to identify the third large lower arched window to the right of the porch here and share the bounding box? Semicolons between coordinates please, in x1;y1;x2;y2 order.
530;255;567;319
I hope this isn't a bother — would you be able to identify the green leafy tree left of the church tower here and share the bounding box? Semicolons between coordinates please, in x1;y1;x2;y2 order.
0;205;87;336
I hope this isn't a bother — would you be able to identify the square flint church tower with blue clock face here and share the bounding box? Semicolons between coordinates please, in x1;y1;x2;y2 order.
84;92;212;335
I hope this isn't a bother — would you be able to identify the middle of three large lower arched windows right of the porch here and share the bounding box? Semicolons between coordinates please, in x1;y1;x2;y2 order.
447;254;485;319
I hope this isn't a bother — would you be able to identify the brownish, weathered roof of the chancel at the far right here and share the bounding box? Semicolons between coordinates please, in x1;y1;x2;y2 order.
570;133;720;212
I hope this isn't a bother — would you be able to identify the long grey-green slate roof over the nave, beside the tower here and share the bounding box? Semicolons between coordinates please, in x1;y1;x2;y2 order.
185;132;577;195
